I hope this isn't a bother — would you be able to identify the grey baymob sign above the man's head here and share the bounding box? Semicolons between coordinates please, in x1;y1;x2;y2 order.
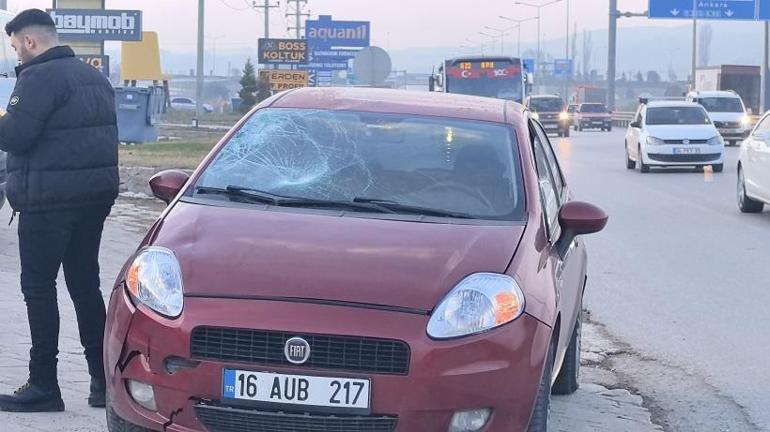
48;9;142;42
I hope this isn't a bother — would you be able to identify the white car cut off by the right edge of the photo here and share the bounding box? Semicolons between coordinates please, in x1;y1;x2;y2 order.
738;112;770;213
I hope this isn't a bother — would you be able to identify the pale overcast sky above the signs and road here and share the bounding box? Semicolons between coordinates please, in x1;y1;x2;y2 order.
8;0;673;52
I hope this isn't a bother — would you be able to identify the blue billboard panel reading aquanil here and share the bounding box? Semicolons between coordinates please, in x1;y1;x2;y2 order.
305;15;371;50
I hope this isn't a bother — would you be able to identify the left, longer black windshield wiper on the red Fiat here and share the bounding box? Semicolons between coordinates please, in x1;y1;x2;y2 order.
195;185;395;213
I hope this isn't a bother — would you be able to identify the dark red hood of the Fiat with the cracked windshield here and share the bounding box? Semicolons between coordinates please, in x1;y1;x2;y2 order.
153;202;524;311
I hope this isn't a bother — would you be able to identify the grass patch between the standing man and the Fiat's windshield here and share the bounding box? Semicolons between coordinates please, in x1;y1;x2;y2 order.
120;141;216;169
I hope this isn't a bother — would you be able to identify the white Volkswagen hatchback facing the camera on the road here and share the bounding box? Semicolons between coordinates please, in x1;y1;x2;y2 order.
626;99;724;173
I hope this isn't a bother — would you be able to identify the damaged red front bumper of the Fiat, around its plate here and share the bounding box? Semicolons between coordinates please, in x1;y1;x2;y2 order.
105;290;551;432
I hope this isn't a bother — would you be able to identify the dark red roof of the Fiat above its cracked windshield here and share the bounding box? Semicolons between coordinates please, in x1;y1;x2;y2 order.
270;87;524;123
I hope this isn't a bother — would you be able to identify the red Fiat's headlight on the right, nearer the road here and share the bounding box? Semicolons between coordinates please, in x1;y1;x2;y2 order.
428;273;524;339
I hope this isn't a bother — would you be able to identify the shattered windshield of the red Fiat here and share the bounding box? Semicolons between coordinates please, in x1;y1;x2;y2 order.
197;108;524;220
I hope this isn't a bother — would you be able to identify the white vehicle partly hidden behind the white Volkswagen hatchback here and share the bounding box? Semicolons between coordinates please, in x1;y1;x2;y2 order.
687;91;751;145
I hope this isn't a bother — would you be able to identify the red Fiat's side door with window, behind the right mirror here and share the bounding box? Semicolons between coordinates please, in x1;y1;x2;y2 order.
530;122;586;370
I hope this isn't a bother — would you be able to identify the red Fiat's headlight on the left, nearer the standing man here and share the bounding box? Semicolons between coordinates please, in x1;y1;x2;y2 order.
126;247;184;318
